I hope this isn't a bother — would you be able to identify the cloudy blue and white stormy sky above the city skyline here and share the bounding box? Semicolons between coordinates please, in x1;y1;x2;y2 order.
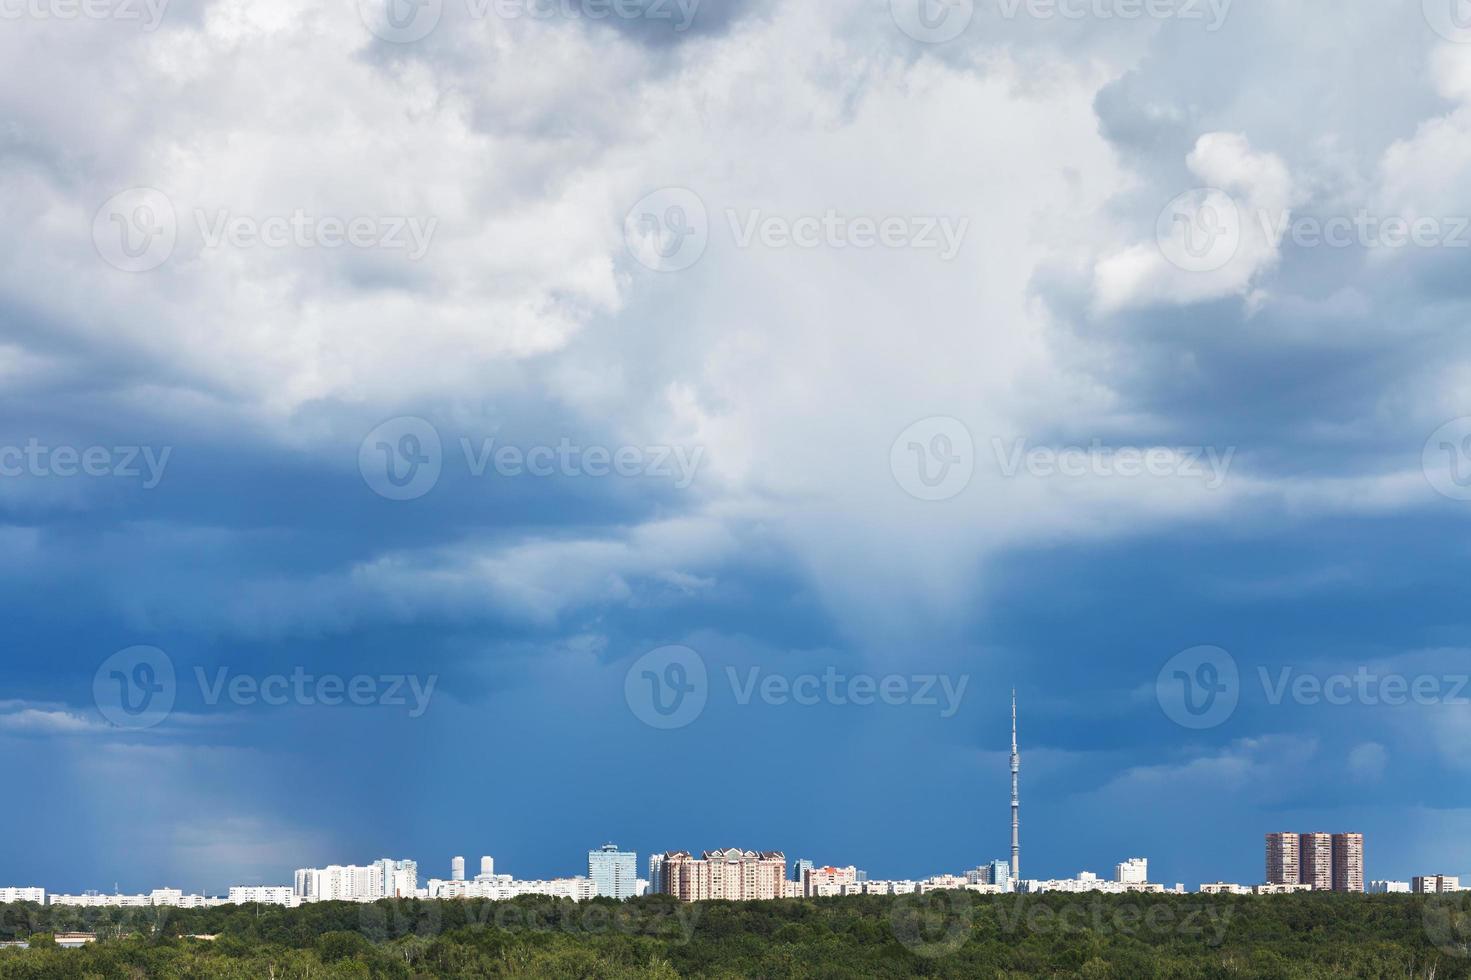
0;0;1471;893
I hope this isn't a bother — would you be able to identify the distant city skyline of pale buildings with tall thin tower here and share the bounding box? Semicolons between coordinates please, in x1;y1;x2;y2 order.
0;692;1461;908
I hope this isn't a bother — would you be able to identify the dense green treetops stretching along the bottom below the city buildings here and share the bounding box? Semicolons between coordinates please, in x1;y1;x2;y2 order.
0;892;1471;980
